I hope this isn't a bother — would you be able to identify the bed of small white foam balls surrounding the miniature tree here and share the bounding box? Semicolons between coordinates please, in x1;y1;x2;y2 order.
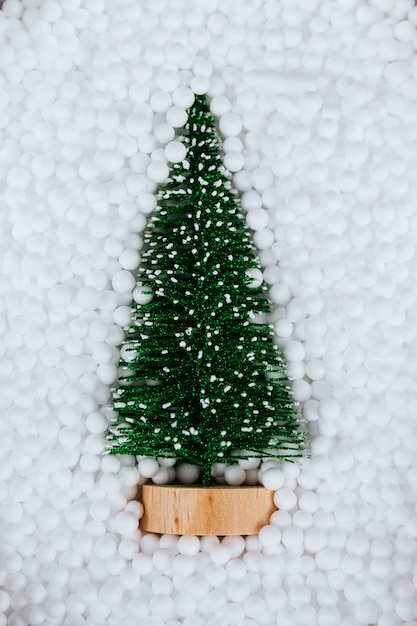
0;0;417;626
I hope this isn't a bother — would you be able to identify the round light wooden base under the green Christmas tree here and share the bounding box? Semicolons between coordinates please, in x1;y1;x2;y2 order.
141;485;275;536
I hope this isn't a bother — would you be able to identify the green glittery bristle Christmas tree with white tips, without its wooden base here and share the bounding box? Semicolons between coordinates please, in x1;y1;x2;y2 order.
109;96;304;485
